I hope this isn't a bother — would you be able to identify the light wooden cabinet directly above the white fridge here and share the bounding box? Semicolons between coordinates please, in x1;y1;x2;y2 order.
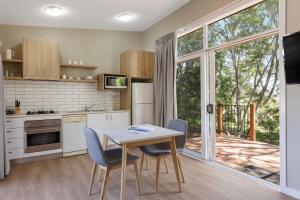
120;50;154;79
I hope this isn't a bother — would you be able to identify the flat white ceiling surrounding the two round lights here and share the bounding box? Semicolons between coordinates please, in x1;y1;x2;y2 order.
0;0;190;31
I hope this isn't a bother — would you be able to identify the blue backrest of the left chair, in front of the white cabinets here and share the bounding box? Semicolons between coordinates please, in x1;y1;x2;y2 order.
83;127;108;166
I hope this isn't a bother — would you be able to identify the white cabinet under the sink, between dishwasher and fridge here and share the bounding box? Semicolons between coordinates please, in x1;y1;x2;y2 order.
87;111;130;144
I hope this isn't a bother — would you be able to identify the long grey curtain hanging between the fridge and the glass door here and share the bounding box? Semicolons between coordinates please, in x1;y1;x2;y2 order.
153;33;175;127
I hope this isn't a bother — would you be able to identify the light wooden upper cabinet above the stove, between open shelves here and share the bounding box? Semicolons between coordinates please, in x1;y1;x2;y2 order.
23;39;60;80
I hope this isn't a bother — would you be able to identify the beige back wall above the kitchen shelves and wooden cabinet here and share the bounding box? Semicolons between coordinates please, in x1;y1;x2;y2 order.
0;25;141;74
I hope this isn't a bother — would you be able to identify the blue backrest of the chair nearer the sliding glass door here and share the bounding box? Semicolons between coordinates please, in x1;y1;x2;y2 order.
167;119;188;148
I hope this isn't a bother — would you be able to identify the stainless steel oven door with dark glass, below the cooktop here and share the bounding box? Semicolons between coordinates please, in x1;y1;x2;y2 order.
25;126;61;153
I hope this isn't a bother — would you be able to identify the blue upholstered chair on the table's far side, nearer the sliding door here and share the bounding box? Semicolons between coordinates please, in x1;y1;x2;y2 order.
140;119;188;192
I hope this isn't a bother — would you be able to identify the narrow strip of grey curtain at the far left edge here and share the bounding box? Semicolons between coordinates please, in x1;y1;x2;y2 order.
0;53;6;179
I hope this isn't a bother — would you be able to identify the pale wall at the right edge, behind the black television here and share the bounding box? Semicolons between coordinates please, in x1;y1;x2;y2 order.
286;0;300;199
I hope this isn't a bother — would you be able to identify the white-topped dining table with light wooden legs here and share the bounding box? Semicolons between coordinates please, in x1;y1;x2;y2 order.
101;124;184;200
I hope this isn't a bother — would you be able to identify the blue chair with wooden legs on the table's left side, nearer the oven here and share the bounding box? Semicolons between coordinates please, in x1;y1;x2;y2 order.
84;127;140;200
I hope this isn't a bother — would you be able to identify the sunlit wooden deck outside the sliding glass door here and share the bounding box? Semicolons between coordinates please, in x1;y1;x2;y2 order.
186;136;280;184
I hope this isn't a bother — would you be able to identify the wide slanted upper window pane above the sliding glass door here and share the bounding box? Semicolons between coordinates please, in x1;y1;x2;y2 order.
208;0;279;47
